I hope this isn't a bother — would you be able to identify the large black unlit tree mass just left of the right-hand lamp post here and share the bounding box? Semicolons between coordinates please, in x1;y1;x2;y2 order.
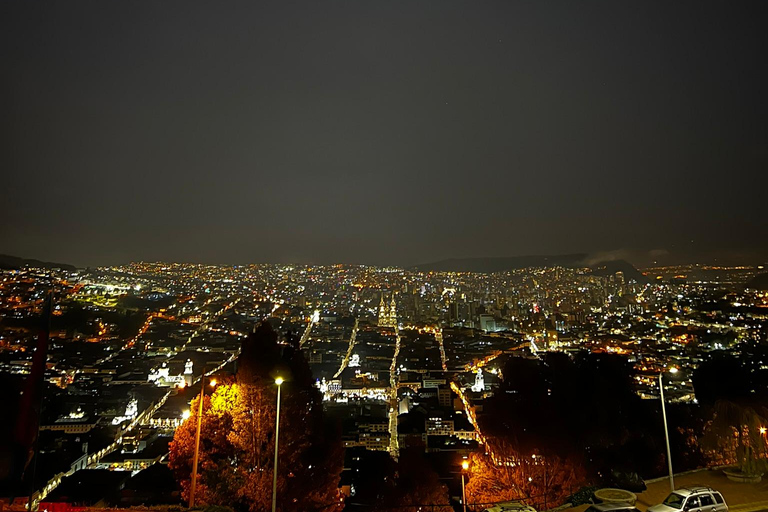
478;353;676;479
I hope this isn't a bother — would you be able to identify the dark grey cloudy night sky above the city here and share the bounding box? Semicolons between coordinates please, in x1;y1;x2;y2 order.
0;0;768;265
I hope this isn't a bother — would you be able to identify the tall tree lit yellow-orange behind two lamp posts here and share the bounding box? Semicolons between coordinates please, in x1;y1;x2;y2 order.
169;323;343;512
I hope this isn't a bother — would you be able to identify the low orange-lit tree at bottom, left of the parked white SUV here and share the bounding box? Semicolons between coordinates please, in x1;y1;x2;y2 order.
466;441;586;510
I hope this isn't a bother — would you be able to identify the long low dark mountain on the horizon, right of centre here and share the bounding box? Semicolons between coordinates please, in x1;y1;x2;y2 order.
413;253;647;283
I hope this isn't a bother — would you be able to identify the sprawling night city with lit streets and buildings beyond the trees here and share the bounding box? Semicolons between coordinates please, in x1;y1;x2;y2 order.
0;263;768;505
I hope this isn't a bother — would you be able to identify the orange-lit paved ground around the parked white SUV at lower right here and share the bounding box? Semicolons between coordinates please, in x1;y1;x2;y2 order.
563;470;768;512
